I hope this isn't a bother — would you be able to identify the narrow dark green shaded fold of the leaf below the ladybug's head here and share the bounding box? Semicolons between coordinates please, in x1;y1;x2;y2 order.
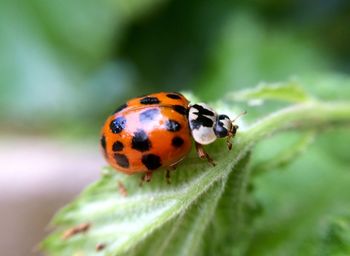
202;153;250;255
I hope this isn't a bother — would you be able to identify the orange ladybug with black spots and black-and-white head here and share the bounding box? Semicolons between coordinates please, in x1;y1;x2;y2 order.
101;92;242;181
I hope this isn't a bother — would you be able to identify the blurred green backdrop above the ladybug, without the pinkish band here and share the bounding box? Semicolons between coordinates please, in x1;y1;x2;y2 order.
0;0;350;136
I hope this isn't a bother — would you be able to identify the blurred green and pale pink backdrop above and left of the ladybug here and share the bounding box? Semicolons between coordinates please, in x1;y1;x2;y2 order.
0;0;350;255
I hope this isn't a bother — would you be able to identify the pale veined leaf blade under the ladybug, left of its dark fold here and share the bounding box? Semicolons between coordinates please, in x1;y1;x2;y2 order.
43;145;252;255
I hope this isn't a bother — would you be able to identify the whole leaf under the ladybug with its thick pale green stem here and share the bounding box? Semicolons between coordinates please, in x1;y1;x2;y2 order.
42;85;350;255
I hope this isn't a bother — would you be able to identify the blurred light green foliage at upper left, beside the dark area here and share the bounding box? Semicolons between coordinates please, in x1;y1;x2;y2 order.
0;0;166;135
